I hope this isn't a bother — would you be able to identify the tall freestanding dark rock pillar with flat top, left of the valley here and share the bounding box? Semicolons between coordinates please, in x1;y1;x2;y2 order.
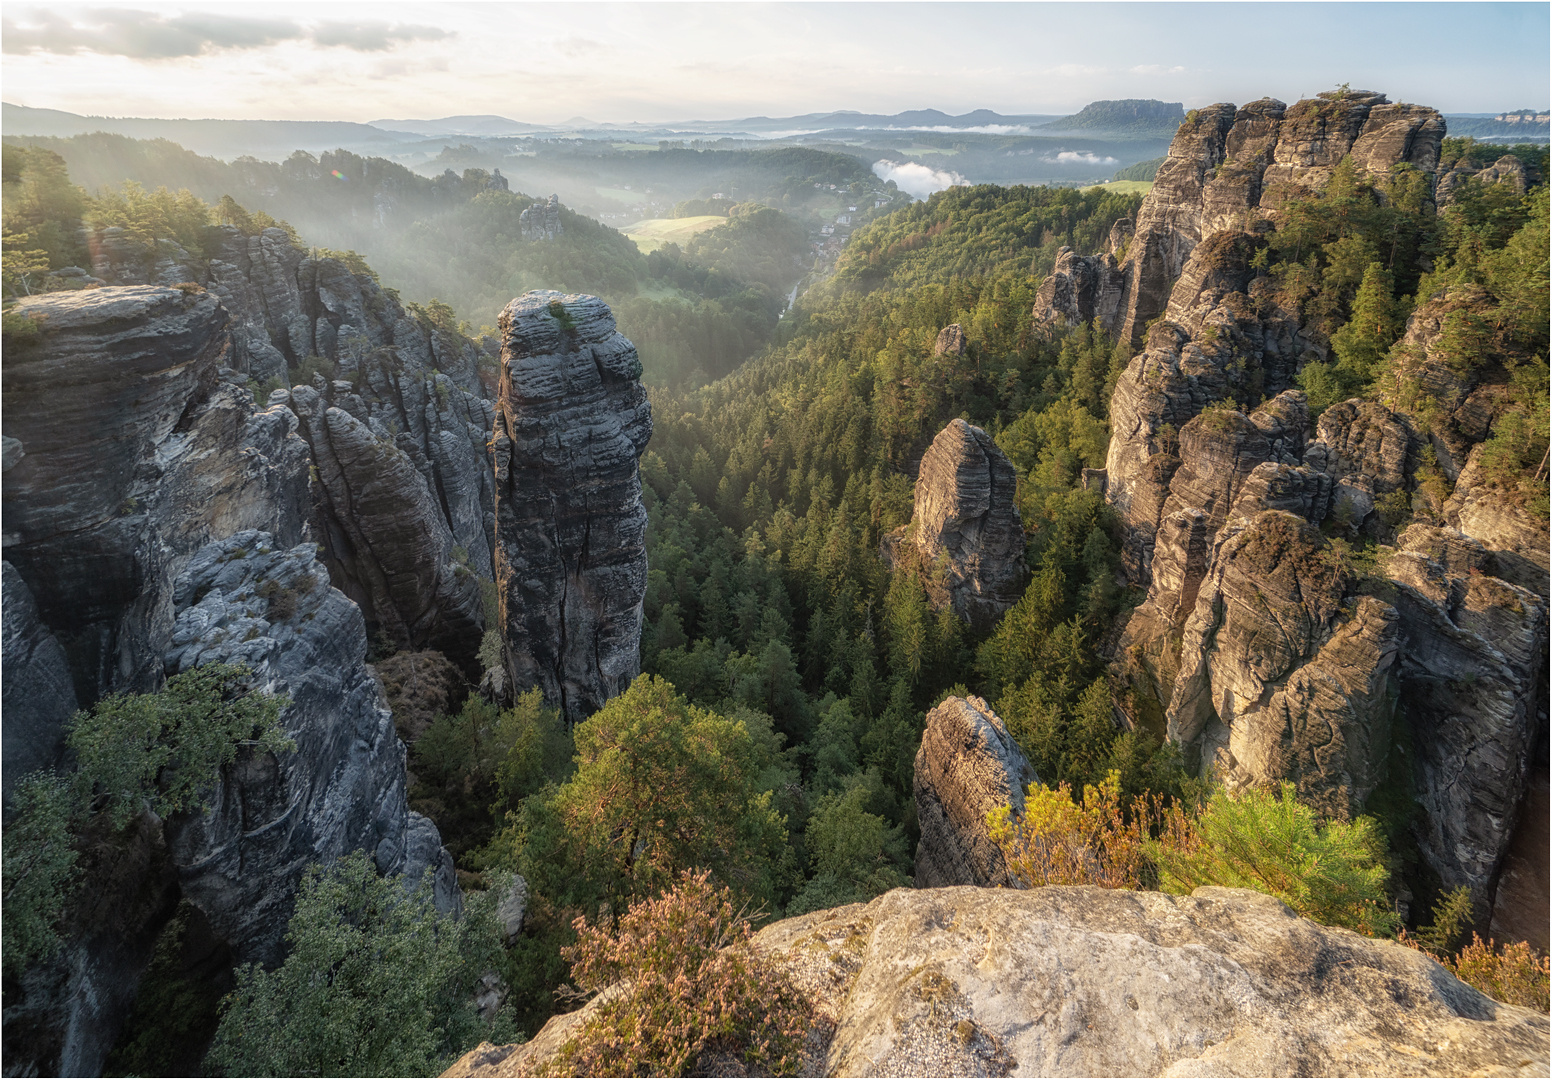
492;292;652;722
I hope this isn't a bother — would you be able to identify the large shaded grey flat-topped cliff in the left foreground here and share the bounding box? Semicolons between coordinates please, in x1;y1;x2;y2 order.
3;286;458;1075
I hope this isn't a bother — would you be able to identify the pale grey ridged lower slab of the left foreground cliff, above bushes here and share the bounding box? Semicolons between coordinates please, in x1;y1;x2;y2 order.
166;531;458;964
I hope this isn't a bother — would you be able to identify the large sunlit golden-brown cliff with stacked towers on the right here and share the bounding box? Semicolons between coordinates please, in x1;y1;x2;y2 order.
1073;93;1547;902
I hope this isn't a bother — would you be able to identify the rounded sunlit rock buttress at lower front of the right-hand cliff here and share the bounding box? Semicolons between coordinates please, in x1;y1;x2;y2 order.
1166;511;1400;818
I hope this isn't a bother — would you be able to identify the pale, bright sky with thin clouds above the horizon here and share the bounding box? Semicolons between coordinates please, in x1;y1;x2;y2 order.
0;0;1552;123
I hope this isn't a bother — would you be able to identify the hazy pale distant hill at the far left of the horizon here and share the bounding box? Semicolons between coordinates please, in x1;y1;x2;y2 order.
0;102;419;160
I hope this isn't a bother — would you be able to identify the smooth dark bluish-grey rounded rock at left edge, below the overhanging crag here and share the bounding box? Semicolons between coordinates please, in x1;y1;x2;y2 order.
0;562;76;805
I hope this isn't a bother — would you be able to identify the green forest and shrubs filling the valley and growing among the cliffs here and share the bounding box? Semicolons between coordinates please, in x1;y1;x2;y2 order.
5;124;1549;1075
